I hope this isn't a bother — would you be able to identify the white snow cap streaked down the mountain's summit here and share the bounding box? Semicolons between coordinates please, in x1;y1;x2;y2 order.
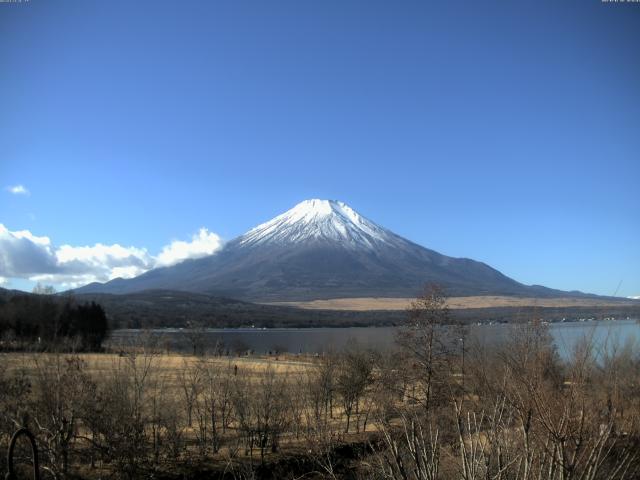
240;199;395;248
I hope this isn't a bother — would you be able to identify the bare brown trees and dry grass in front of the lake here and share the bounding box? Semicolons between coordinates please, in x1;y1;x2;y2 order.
0;291;640;480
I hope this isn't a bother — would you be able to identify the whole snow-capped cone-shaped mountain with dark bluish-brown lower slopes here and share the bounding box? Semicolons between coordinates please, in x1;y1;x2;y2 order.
76;200;581;302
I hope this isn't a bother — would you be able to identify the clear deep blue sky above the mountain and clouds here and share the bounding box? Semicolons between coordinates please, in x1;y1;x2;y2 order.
0;0;640;296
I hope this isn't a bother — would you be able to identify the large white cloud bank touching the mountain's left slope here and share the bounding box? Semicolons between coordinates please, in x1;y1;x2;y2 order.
0;224;222;288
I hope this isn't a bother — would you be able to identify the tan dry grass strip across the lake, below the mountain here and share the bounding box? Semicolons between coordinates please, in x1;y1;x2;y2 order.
270;296;632;311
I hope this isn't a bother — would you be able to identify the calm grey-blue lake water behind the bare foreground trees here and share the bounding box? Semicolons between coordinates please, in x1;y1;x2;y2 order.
109;320;640;357
